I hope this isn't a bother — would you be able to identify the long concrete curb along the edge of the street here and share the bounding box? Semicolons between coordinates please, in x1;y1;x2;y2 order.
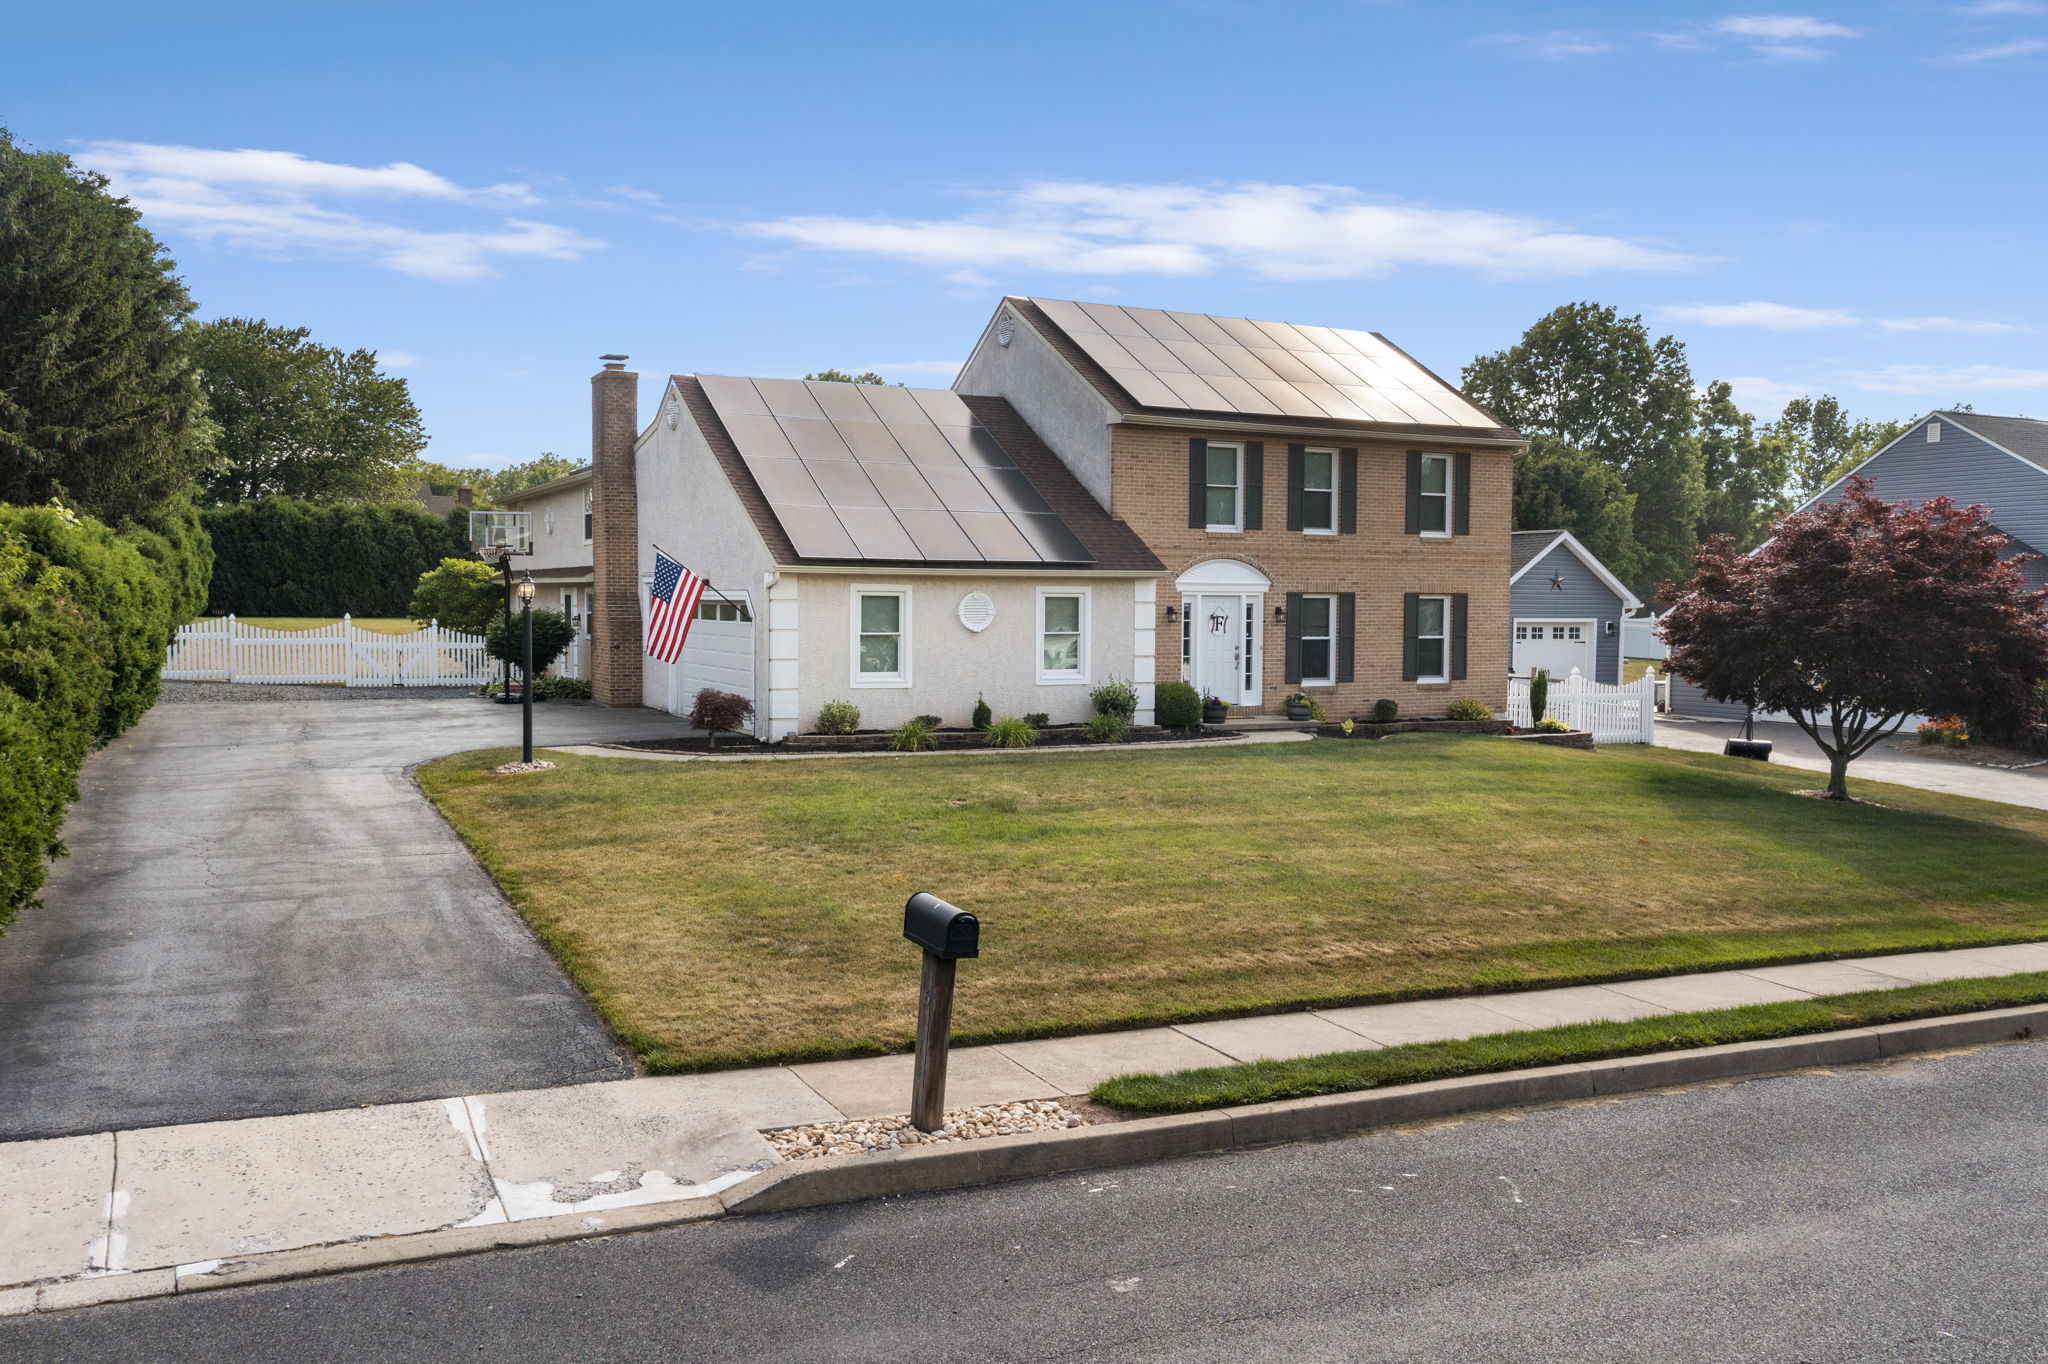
12;1004;2048;1317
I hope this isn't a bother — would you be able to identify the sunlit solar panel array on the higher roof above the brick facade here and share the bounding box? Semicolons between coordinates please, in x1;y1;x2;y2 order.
1032;299;1495;428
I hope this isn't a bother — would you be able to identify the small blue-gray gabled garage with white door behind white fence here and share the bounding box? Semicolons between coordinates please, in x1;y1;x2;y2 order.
1507;530;1642;686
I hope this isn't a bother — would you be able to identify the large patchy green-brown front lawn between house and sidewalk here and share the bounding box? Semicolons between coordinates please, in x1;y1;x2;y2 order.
420;735;2048;1071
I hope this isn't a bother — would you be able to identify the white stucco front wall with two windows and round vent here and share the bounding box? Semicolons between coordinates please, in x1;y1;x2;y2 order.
784;571;1155;731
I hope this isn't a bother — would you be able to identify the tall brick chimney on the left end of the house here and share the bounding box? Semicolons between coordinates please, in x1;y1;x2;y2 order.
590;354;641;707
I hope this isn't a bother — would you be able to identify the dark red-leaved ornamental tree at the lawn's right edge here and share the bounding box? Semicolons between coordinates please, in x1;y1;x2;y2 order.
1663;477;2048;801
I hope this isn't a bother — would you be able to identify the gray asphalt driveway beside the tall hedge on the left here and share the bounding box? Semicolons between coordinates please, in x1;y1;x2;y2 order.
0;684;680;1141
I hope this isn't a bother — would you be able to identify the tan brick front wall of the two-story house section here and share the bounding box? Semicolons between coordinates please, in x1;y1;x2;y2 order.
1110;424;1513;719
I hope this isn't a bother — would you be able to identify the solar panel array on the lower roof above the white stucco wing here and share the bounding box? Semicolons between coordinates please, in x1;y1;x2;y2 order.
698;375;1094;563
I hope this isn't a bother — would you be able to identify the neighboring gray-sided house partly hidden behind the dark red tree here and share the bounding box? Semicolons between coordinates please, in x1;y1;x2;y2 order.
1671;410;2048;719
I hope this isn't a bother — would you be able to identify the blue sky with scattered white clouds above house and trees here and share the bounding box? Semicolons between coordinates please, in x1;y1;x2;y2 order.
16;0;2048;465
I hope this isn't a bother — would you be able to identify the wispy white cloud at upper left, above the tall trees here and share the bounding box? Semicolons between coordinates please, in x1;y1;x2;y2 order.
78;141;602;281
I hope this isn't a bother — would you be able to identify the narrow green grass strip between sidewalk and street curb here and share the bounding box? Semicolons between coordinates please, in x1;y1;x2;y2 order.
1090;971;2048;1112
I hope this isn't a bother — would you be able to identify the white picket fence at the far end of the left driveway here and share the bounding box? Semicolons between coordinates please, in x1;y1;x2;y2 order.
164;616;496;686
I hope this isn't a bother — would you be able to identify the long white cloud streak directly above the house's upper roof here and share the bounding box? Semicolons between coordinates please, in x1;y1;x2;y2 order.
745;180;1700;281
